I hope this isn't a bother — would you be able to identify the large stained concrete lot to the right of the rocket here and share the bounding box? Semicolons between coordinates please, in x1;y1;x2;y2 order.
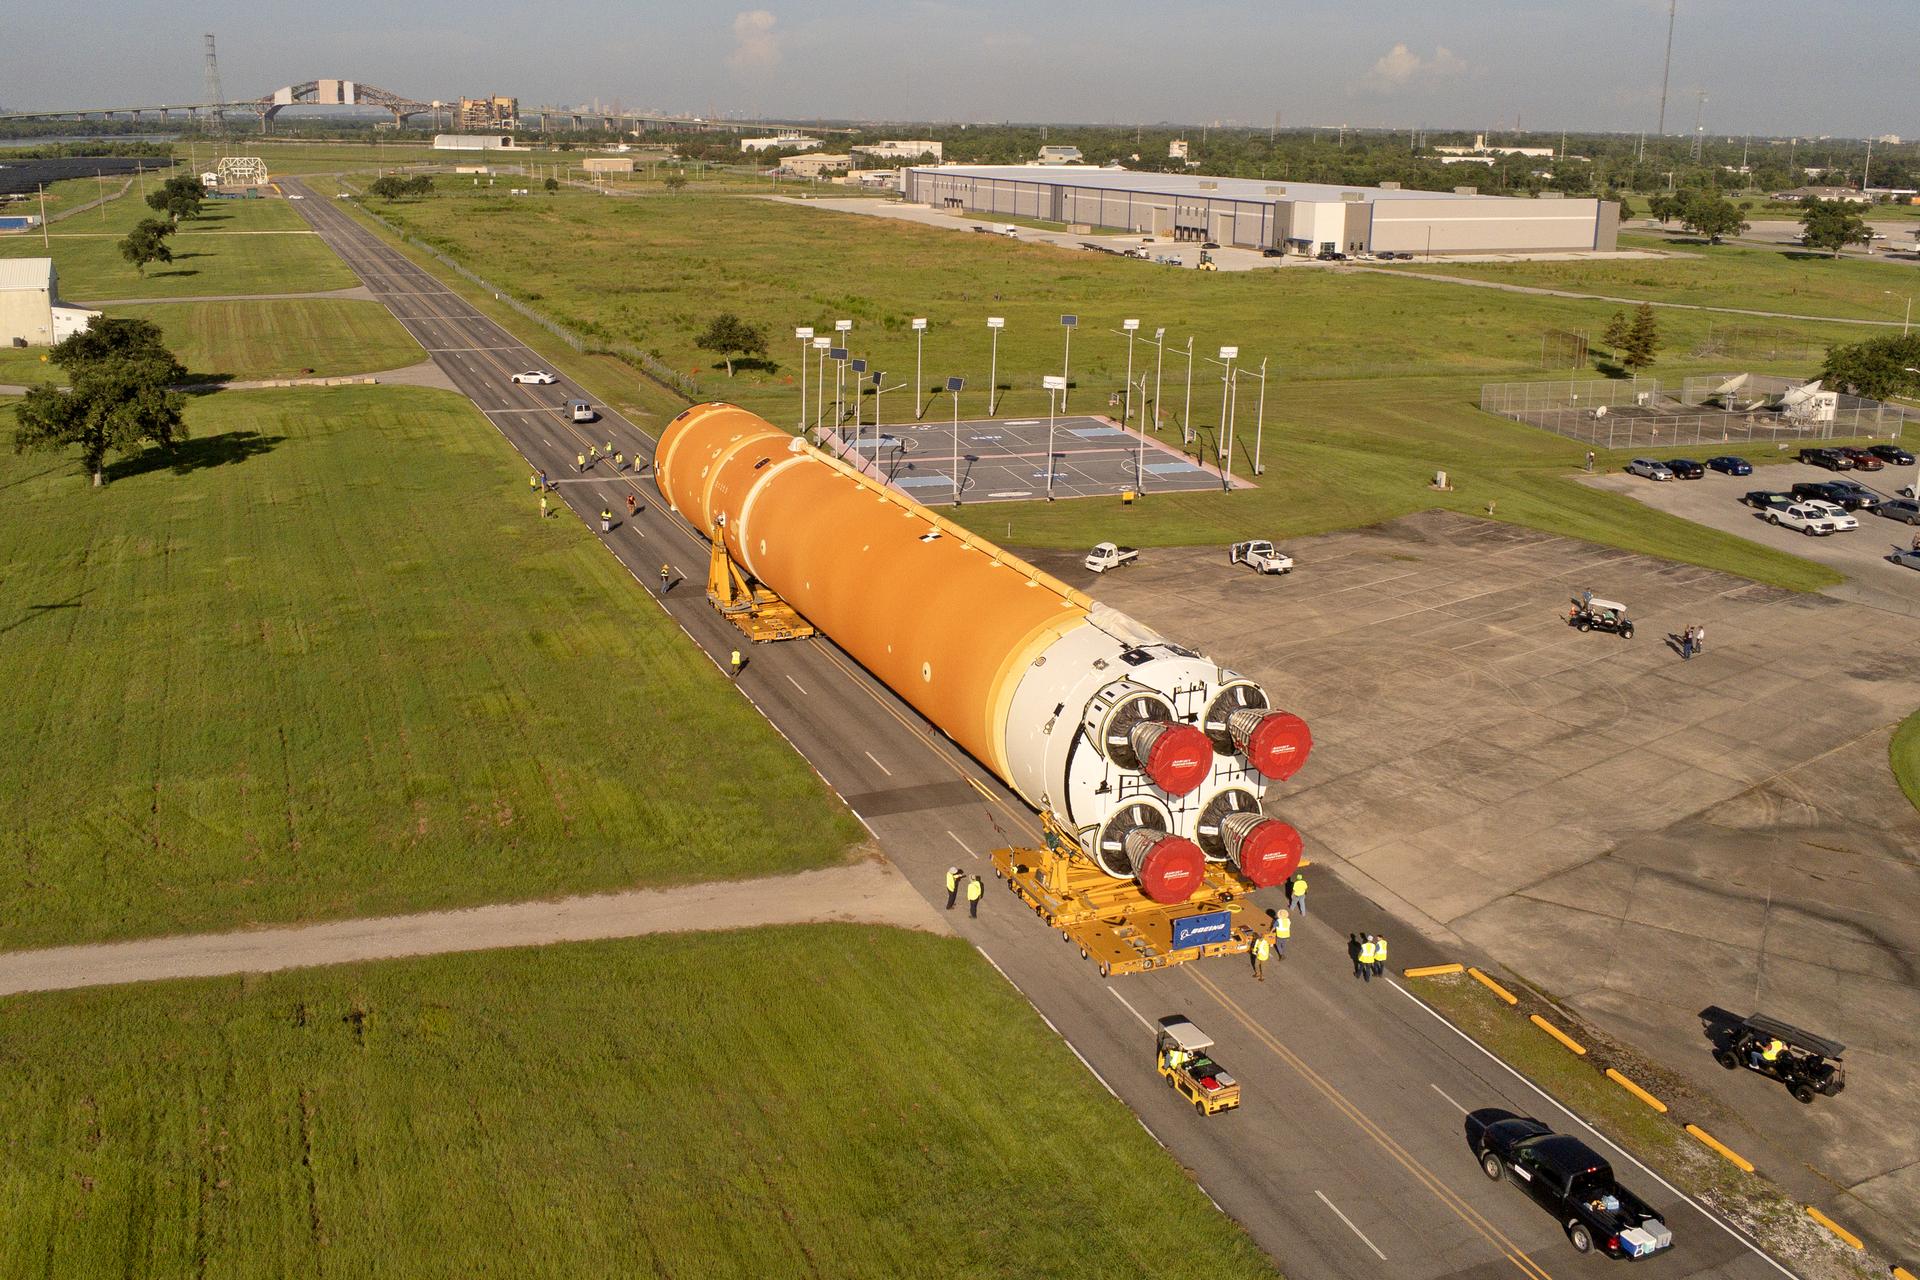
1033;506;1920;1249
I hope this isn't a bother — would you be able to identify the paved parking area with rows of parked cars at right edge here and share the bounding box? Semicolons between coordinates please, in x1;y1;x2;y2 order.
1590;453;1920;616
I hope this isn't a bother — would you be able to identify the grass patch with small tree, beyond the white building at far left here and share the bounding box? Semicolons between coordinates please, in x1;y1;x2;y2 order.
0;191;359;303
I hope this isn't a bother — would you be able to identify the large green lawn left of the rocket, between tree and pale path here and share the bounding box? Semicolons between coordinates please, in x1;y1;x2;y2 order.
0;388;860;946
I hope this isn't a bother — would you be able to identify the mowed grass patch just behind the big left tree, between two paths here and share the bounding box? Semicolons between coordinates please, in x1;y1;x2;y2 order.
0;297;426;384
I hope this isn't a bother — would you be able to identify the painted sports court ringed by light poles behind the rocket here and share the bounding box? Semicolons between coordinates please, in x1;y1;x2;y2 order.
822;415;1246;503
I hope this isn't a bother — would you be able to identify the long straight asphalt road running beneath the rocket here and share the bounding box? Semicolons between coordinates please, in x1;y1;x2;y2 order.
294;184;1791;1280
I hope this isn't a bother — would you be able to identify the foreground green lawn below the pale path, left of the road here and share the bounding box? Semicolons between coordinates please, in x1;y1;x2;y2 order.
0;925;1275;1280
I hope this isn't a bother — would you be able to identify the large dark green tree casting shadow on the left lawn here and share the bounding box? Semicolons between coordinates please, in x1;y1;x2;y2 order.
13;319;186;486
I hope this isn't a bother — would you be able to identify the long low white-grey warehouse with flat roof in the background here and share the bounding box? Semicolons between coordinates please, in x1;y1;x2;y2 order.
902;165;1620;255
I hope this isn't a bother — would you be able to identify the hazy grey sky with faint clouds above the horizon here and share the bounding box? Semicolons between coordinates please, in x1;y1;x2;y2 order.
0;0;1920;136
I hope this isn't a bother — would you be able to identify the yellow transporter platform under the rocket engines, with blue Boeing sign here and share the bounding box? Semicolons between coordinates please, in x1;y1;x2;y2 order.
993;812;1258;977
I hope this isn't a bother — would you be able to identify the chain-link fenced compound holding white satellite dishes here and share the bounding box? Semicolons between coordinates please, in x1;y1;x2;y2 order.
1480;374;1920;449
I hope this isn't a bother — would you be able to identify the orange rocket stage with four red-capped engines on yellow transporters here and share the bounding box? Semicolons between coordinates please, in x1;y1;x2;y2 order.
655;405;1311;967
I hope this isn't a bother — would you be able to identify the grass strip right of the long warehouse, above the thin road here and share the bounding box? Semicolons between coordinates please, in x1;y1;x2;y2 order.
1419;236;1920;326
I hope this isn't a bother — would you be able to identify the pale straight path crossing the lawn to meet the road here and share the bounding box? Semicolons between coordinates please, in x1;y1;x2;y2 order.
0;858;947;996
